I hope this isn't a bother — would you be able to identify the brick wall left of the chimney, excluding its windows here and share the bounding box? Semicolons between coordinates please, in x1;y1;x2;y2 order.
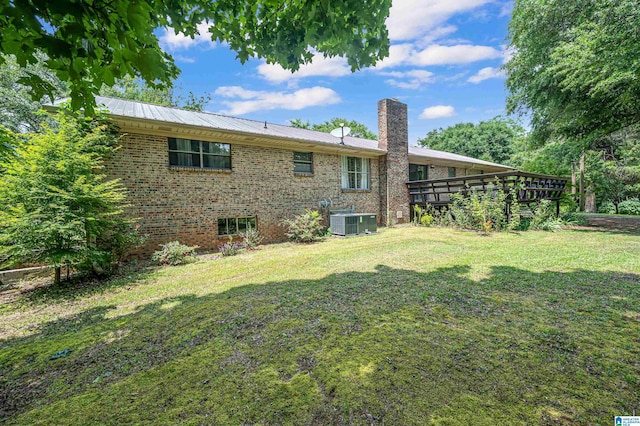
106;134;380;253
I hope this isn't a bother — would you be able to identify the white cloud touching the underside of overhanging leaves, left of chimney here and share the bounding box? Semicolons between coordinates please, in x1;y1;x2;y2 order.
258;53;351;83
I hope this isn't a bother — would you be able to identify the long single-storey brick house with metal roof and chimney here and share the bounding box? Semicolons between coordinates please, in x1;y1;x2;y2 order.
76;97;509;252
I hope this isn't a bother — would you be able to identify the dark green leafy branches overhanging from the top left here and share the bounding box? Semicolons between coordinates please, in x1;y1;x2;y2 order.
0;0;391;112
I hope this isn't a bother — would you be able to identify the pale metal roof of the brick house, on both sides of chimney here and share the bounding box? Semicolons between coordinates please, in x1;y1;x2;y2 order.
54;96;511;169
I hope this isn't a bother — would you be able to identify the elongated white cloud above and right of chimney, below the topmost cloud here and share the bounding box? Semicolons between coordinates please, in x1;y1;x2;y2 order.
410;44;503;66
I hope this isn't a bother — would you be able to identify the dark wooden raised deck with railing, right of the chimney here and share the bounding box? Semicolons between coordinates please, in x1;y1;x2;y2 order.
407;170;568;210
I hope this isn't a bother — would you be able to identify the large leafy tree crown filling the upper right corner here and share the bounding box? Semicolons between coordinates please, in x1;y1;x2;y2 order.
505;0;640;148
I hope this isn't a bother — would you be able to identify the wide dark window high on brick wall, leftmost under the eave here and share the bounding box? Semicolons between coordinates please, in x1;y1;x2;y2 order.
169;138;231;170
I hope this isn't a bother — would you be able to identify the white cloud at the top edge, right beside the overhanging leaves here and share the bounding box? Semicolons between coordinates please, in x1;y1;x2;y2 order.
387;0;492;41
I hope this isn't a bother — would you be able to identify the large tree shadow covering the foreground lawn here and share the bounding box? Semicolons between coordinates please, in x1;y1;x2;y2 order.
0;266;640;424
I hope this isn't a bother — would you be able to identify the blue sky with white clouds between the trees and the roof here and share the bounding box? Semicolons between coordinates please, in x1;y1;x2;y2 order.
159;0;512;145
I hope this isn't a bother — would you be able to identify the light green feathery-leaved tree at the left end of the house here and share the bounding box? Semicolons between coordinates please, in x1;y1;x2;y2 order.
0;111;140;274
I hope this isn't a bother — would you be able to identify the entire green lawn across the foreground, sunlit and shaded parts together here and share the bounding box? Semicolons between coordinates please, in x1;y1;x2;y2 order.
0;227;640;425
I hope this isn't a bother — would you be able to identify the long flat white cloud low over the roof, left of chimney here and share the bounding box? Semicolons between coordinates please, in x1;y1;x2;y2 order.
215;86;342;115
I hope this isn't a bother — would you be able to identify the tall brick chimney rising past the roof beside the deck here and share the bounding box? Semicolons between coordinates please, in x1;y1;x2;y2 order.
378;99;409;224
